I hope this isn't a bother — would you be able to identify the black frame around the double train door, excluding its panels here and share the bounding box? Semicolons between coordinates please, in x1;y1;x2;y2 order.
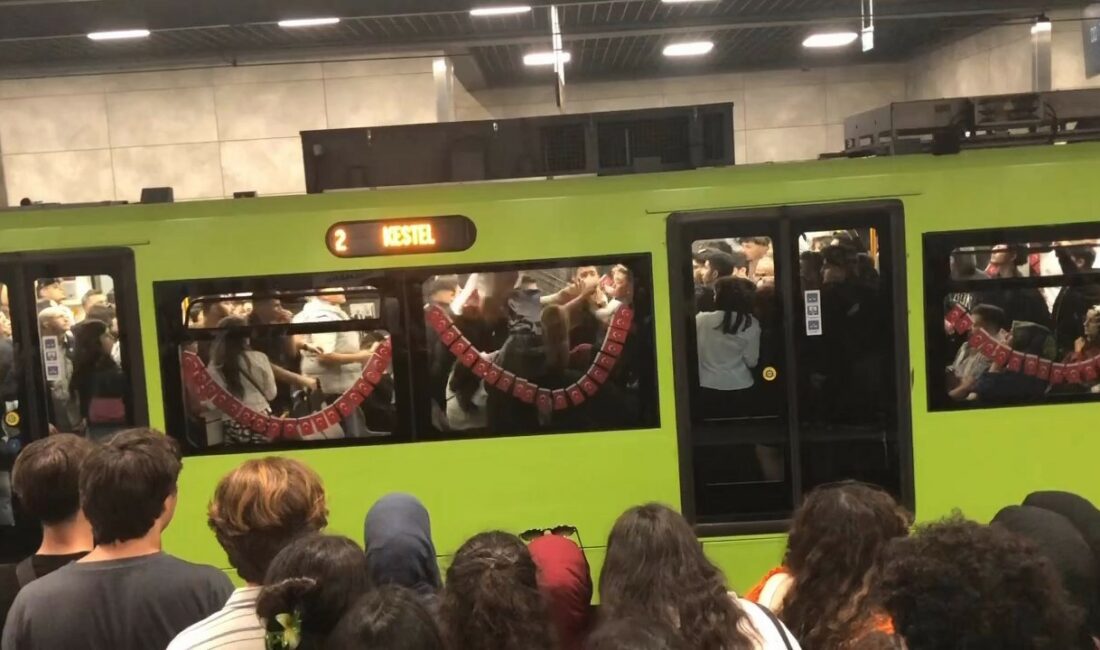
667;200;916;537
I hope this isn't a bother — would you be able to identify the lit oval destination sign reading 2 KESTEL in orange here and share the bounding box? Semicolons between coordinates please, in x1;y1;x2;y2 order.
326;216;477;257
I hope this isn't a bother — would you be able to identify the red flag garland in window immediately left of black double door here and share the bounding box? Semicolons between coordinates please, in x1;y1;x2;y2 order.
426;305;634;412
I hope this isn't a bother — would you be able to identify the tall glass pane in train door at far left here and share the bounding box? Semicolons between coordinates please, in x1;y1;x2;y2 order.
35;275;133;440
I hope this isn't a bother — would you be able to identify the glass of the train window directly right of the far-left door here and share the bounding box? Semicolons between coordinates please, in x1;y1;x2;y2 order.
182;286;396;448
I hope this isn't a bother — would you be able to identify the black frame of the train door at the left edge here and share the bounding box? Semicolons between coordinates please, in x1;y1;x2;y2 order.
0;247;149;445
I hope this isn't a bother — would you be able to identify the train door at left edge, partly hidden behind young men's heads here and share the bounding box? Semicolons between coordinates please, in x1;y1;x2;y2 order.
0;249;149;562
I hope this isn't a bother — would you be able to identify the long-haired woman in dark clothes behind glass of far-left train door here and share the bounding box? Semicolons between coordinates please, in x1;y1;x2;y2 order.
69;319;132;440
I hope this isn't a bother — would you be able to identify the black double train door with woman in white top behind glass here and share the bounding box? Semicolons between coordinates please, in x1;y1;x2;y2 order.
669;202;912;533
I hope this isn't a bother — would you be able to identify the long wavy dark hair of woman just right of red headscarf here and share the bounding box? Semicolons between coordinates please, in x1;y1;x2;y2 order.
600;504;755;650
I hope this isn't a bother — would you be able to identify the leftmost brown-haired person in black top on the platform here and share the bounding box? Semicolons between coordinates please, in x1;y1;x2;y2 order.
0;433;94;618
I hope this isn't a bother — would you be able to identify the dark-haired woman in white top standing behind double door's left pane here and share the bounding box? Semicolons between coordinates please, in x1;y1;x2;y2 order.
695;277;761;419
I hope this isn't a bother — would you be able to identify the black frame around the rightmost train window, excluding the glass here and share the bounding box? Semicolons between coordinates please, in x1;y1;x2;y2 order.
922;222;1100;412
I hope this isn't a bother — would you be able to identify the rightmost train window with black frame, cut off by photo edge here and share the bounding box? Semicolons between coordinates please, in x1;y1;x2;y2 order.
925;224;1100;410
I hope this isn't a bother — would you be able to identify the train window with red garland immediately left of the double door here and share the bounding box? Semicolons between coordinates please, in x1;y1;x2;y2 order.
422;256;658;437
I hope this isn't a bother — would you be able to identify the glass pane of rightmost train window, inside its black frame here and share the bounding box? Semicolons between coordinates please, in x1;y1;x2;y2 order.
930;239;1100;405
